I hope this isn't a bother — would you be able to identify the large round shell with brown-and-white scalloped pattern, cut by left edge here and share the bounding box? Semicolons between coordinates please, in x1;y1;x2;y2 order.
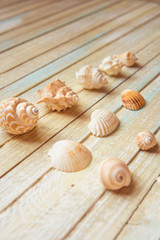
0;98;38;135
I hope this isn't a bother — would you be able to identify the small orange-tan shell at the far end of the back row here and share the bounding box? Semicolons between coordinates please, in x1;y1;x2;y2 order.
113;52;138;67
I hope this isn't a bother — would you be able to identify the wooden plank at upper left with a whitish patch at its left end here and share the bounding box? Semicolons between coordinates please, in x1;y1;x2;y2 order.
0;0;89;34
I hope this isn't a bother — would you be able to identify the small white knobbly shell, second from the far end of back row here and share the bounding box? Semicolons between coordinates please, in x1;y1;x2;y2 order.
99;57;123;76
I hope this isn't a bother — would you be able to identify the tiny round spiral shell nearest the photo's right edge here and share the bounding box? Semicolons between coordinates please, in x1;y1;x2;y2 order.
136;131;157;150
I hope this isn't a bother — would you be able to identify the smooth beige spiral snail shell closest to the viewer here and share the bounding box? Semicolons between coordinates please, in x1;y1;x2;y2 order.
99;158;131;190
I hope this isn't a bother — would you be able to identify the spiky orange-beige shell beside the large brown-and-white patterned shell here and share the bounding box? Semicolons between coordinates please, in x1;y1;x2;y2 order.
37;79;79;112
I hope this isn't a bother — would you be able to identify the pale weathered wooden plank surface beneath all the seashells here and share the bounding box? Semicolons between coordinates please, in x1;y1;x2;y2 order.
0;0;160;240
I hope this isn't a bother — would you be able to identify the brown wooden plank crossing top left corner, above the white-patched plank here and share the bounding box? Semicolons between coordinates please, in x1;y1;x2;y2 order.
0;0;54;20
